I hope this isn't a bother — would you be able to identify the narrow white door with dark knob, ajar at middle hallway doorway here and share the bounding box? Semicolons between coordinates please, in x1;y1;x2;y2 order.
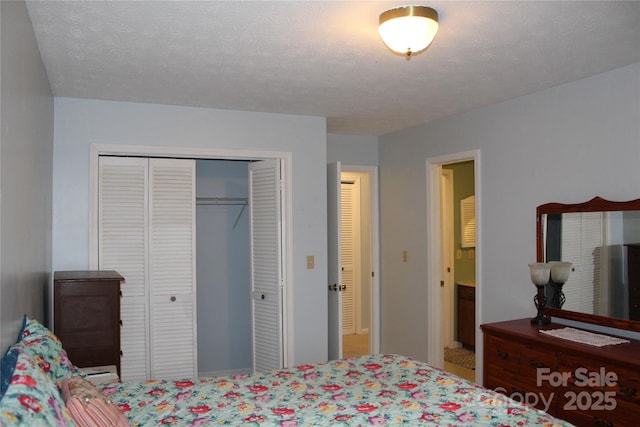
327;162;342;360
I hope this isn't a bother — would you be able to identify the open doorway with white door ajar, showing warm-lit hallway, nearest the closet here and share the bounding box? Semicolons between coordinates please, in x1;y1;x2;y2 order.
328;163;379;359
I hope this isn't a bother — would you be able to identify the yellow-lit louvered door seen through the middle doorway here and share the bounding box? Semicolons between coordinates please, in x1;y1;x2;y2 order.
340;184;356;335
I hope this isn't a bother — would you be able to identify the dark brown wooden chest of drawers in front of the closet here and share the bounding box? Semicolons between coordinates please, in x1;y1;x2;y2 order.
53;270;124;375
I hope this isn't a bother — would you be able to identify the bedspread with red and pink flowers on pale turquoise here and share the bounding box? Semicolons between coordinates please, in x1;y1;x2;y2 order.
102;354;569;427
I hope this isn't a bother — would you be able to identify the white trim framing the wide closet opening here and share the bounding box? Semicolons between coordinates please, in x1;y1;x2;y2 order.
89;144;295;367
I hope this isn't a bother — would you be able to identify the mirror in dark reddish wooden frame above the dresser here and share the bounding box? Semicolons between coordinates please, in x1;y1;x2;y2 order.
536;197;640;332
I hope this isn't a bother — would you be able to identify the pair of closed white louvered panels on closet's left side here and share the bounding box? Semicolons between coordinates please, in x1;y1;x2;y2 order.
98;156;197;381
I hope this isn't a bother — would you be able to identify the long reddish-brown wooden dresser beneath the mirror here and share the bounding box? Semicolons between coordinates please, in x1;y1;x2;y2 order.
481;319;640;427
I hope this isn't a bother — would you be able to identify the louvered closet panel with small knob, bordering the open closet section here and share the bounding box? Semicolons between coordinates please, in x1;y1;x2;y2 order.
149;159;198;378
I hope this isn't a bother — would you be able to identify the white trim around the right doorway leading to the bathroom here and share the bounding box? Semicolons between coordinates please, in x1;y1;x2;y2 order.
426;150;482;381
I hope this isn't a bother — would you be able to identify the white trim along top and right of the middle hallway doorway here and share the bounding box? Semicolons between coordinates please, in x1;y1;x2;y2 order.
340;164;380;354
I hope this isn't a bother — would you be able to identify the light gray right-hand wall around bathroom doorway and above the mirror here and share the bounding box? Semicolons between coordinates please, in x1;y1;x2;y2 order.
380;64;640;360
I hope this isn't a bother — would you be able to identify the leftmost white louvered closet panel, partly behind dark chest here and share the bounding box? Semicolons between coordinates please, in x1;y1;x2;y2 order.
98;156;149;381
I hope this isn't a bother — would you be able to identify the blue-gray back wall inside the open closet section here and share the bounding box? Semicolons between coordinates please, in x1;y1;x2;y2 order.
196;160;253;376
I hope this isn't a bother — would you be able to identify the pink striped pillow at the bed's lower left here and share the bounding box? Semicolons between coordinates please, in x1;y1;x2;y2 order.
62;375;129;427
